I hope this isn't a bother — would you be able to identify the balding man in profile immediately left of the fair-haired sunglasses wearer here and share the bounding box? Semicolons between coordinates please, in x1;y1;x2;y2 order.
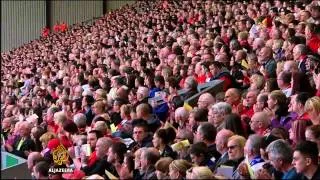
215;129;234;170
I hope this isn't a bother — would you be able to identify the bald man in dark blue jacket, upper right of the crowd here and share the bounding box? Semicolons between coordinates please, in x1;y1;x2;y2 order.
258;47;277;78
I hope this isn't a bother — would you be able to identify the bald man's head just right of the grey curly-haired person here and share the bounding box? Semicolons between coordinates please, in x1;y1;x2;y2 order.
250;111;271;136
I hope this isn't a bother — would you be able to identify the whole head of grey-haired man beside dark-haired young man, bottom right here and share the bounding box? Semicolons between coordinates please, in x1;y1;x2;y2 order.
266;139;293;171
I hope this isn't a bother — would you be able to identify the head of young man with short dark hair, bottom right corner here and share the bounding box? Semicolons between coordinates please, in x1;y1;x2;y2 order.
292;141;319;174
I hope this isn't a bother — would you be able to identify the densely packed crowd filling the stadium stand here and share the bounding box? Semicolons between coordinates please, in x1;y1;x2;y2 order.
1;0;320;179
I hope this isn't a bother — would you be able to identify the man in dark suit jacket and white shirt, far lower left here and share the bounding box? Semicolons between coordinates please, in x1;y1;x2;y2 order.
5;121;35;159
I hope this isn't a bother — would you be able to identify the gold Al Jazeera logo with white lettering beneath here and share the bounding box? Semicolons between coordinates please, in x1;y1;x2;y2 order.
49;144;73;173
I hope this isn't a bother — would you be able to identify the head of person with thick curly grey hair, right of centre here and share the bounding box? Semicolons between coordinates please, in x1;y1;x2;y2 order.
208;102;232;131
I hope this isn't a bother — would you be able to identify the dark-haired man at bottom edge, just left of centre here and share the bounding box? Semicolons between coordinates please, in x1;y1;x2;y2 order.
140;148;160;179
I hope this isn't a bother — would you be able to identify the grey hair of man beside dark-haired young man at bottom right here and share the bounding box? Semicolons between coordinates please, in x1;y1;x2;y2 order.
266;139;293;163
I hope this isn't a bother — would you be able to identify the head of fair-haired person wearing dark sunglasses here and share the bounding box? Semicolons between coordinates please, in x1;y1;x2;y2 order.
228;135;246;160
